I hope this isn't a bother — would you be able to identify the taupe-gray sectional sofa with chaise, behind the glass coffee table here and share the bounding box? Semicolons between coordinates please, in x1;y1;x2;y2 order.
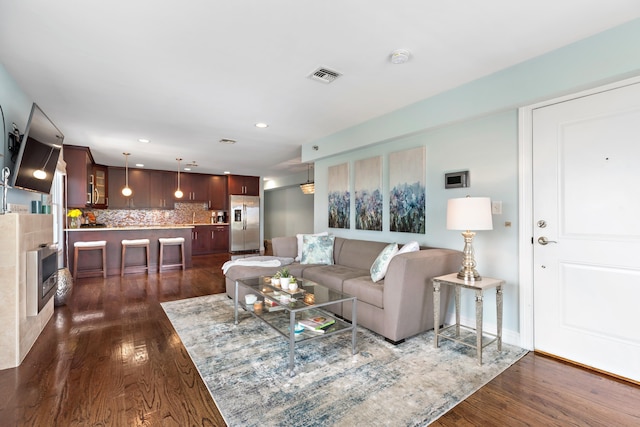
226;236;462;343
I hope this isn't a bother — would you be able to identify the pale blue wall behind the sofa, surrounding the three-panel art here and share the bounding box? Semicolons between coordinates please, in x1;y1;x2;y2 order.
302;20;640;342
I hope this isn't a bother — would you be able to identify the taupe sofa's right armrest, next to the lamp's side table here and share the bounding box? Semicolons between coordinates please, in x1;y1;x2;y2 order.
383;249;462;341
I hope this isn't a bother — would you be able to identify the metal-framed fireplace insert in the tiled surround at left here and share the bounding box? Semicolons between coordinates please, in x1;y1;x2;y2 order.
27;246;58;316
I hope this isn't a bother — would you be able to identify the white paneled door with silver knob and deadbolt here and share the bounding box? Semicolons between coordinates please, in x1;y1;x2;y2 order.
533;84;640;381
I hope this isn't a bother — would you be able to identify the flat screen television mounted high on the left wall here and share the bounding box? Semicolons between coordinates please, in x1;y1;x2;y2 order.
13;103;64;194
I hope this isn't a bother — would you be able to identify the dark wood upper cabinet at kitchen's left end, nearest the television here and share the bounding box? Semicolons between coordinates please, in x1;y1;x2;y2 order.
63;144;93;208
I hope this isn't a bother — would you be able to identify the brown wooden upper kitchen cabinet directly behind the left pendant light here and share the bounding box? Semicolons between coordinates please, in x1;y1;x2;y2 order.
109;167;151;209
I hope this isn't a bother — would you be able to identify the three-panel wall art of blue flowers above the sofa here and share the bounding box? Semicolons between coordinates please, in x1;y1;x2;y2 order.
328;147;426;234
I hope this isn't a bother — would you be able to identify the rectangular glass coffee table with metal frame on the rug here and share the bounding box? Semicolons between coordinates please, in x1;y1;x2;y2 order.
234;276;358;376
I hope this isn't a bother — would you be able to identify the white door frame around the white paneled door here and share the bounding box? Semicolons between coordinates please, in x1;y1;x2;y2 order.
518;76;640;350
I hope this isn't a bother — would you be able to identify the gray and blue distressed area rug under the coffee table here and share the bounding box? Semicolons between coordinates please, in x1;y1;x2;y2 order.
162;295;527;427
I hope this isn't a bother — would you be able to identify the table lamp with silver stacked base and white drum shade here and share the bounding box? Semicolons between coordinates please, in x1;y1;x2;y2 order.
447;196;493;281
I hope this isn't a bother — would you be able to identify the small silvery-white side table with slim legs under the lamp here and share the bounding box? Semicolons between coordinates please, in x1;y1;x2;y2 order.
432;273;505;365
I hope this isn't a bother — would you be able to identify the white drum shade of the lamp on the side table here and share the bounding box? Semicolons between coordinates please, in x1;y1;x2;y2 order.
447;197;493;230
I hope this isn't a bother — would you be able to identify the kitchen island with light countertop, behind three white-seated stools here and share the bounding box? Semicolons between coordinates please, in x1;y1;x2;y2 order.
65;225;194;276
